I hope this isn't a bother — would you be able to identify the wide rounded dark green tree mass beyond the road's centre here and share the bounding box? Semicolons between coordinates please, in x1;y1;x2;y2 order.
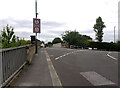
62;31;92;47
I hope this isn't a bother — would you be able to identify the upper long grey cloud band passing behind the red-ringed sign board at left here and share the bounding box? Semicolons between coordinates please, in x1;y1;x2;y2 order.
0;18;65;29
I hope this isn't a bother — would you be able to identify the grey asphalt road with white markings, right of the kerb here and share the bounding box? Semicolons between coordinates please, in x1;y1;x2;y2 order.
45;48;118;86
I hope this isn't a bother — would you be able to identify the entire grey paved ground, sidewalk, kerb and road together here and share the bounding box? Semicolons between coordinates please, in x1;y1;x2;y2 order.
12;48;118;88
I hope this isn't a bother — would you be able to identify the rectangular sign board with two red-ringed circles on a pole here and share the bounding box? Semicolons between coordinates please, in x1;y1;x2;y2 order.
33;18;40;33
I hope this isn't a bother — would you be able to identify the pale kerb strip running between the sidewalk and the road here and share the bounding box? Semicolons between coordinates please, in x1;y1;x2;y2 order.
45;50;63;88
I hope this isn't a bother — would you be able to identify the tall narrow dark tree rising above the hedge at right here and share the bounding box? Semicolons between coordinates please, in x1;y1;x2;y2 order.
93;17;106;42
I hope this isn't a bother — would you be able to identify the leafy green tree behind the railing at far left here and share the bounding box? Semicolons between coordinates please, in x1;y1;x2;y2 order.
1;25;16;48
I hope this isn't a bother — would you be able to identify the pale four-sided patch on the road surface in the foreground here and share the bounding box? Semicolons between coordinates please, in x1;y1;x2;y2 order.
80;71;115;86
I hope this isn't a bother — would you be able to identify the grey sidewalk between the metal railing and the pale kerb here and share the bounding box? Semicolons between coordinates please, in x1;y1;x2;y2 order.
12;49;52;86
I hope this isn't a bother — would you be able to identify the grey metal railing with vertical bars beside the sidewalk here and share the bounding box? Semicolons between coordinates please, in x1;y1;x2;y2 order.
0;46;27;87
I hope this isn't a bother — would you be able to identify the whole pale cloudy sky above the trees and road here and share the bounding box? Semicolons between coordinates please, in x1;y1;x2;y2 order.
0;0;119;42
